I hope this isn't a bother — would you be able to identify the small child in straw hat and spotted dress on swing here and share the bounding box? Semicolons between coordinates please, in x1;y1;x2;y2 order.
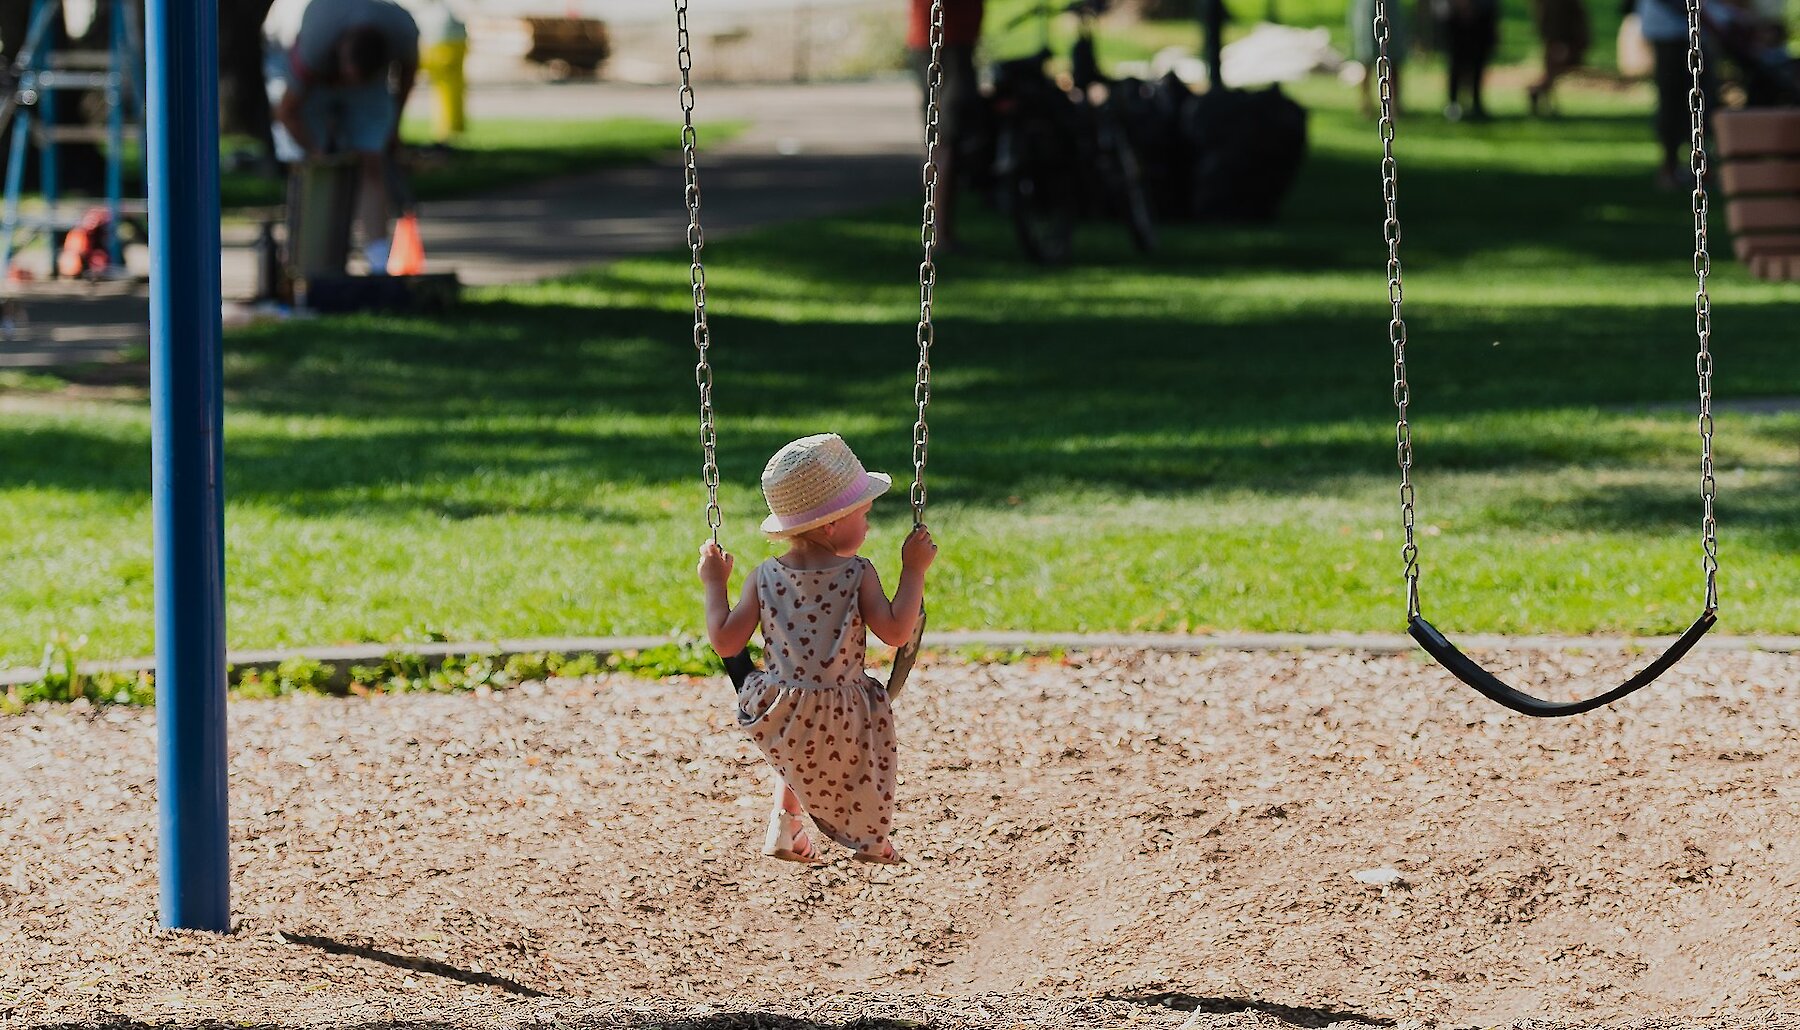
700;434;938;863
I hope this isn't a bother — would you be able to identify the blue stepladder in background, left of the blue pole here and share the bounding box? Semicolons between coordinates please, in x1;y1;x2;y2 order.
0;0;149;288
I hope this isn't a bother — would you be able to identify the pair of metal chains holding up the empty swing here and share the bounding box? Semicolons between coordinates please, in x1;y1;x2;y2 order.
1375;0;1719;618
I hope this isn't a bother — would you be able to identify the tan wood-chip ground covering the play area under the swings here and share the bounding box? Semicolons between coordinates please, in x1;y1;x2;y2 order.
0;652;1800;1030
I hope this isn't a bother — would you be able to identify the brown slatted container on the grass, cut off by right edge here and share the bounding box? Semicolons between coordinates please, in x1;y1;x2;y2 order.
1714;108;1800;281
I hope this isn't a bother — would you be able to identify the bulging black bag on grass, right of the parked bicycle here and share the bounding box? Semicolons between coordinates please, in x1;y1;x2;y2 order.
1179;86;1307;221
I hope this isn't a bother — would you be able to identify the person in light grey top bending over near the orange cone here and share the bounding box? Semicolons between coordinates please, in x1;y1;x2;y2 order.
263;0;419;272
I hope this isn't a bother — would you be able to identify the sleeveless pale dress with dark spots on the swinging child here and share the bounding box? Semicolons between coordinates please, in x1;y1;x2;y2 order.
738;558;900;852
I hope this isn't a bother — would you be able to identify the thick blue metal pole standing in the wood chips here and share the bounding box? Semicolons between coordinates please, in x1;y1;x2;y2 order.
146;0;230;931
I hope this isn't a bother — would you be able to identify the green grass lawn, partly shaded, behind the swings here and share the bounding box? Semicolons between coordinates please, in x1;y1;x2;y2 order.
0;83;1800;663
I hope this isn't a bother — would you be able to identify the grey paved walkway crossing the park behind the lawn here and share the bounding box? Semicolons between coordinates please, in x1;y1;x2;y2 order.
0;79;920;369
